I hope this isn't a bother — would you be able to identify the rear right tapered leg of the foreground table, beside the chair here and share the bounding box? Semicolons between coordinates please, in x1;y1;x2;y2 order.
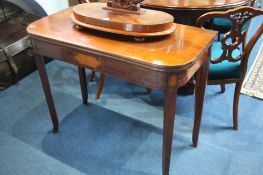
192;59;209;147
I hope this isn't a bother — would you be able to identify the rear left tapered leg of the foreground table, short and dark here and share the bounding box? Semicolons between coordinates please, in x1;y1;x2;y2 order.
78;66;88;104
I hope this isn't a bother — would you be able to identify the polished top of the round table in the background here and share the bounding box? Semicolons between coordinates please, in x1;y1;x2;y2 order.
143;0;251;10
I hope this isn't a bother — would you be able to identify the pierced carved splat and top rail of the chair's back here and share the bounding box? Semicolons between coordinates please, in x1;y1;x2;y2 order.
196;7;263;63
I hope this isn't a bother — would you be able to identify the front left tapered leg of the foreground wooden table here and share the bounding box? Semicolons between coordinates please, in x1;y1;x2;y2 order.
35;54;59;133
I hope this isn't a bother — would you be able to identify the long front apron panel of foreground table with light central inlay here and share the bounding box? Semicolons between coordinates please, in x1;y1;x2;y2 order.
32;36;166;89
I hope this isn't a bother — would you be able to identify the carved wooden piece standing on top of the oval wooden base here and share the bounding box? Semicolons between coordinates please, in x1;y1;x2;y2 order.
104;0;143;14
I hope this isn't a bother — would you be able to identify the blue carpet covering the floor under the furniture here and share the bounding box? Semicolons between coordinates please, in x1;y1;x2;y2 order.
0;18;263;175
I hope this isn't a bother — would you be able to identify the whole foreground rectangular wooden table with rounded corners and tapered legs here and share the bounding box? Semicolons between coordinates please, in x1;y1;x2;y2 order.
27;8;217;175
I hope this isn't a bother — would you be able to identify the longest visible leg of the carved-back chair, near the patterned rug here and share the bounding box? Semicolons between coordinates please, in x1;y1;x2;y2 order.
233;82;242;130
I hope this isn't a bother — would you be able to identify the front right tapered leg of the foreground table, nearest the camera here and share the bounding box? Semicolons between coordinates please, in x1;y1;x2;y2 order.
162;86;177;175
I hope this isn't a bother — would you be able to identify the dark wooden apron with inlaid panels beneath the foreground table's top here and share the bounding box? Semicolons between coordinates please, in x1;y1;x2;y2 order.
31;38;208;91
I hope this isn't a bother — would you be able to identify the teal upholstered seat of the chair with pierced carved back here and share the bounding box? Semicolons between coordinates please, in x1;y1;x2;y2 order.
208;42;242;80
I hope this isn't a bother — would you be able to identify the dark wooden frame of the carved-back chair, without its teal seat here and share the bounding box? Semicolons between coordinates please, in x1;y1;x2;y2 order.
196;7;263;130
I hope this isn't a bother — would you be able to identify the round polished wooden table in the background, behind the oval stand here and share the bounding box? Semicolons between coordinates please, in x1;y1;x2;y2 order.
142;0;254;25
